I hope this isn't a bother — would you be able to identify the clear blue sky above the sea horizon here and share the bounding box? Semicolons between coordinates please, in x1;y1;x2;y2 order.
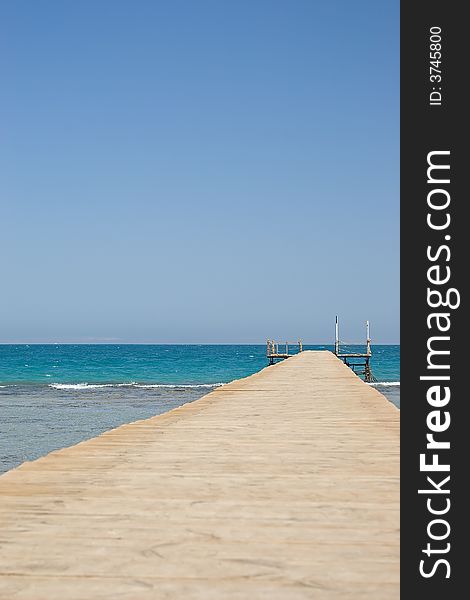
0;0;399;343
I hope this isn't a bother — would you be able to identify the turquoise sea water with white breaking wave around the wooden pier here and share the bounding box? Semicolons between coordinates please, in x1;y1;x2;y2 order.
0;344;400;472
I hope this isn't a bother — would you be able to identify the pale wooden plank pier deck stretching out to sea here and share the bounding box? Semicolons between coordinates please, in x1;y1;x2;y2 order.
0;351;399;600
